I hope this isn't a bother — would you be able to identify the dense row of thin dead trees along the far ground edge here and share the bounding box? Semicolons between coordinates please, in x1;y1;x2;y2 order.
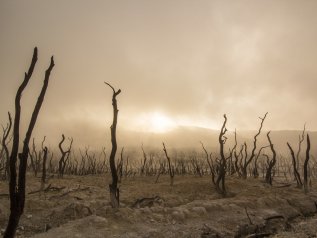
1;129;317;186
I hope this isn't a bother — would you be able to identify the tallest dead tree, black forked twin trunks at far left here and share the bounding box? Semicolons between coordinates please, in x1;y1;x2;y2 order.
4;47;54;238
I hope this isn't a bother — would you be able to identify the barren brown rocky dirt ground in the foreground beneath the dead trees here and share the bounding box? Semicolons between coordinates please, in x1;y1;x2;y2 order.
0;175;317;238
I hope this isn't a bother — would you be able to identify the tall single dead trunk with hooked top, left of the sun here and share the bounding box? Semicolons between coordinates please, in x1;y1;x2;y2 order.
105;82;121;208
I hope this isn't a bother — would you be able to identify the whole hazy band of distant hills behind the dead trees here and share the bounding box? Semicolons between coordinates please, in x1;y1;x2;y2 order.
34;122;317;158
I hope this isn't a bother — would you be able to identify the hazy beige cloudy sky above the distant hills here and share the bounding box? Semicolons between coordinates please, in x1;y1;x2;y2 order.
0;0;317;147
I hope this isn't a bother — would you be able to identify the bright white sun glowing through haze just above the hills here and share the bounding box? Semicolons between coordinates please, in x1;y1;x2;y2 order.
137;112;176;133
